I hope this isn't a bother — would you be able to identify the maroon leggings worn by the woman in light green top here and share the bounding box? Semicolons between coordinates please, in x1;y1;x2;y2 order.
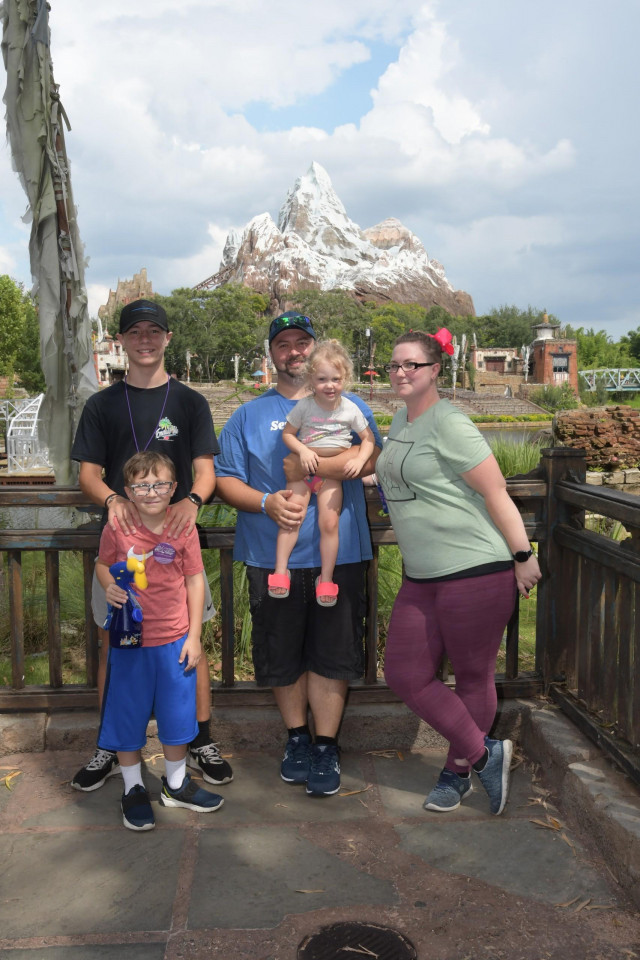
385;570;516;773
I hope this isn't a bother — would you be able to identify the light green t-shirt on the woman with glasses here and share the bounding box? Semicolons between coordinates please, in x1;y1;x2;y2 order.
376;400;512;579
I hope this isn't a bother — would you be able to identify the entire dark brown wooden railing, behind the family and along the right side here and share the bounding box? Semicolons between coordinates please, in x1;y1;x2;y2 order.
0;448;640;783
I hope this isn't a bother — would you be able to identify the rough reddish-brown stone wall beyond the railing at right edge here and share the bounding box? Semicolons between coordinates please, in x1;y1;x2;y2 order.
553;406;640;470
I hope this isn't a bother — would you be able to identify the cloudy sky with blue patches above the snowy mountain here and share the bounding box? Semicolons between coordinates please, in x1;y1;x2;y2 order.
0;0;640;339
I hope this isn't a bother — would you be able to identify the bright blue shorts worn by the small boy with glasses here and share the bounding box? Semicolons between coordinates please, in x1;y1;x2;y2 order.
98;634;198;752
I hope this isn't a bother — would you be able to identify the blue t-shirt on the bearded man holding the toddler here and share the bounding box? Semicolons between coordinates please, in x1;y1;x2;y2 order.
216;390;382;570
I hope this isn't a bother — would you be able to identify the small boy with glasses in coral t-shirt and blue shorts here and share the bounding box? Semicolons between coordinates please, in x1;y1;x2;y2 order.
96;451;224;830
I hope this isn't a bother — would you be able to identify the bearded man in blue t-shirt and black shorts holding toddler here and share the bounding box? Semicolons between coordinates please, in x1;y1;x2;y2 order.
216;311;382;796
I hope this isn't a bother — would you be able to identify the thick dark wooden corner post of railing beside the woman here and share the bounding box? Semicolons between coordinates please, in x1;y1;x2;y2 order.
536;447;586;689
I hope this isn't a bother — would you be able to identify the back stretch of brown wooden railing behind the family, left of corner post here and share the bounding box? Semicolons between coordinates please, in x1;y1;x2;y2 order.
0;478;546;712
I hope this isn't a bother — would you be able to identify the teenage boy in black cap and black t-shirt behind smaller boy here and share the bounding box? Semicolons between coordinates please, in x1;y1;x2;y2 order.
71;300;233;791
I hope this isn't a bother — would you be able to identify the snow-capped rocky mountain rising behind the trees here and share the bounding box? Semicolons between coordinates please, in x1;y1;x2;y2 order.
206;163;475;315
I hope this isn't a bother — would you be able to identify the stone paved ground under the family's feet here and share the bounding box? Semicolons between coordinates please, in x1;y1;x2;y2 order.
0;711;640;960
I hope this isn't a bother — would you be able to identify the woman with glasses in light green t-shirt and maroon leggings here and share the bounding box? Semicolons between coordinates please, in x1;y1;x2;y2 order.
376;329;540;815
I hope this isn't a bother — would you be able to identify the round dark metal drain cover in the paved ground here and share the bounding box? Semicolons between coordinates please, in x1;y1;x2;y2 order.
298;923;418;960
